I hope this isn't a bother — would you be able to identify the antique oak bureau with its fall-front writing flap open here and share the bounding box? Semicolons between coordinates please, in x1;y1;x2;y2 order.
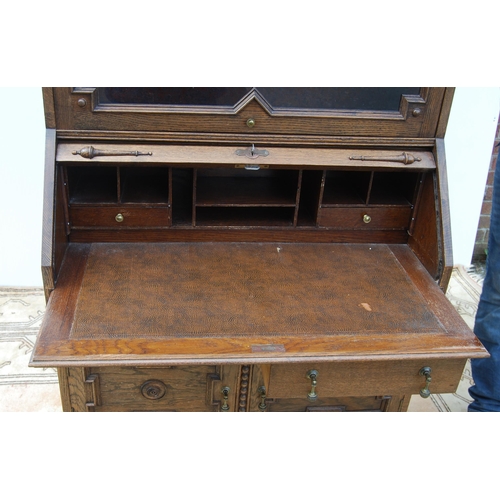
31;87;487;411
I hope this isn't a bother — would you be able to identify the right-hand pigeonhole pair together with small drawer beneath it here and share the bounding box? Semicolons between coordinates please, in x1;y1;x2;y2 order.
317;170;422;230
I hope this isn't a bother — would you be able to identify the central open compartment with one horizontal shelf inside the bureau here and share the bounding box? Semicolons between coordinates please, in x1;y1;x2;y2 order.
193;166;302;227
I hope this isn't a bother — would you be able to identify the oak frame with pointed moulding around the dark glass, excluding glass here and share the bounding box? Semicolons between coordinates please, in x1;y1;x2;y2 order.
50;87;450;137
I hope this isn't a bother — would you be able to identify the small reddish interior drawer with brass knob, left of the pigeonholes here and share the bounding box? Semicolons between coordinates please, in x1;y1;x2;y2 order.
70;206;171;228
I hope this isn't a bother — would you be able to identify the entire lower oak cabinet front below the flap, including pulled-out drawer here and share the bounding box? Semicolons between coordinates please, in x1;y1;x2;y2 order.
59;360;465;412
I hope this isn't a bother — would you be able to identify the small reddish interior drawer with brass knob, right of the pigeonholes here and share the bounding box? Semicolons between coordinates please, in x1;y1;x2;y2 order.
318;205;411;230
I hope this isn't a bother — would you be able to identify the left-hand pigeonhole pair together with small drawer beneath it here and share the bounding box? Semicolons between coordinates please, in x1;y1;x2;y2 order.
66;164;172;229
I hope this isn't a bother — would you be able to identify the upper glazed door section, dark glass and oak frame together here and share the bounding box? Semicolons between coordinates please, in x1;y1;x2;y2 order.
51;87;450;138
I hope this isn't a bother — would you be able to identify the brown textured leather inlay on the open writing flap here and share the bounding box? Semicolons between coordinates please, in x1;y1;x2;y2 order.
71;243;444;339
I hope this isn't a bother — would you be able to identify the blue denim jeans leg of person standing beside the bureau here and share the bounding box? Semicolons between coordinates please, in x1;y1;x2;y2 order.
468;151;500;411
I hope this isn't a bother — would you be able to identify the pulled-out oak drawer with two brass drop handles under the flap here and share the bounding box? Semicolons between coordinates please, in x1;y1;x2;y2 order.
259;359;465;400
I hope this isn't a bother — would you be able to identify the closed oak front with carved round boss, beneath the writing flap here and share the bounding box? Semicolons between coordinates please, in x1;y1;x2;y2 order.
68;366;229;412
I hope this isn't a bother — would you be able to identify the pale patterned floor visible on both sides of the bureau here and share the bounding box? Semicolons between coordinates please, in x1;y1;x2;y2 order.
0;265;484;412
